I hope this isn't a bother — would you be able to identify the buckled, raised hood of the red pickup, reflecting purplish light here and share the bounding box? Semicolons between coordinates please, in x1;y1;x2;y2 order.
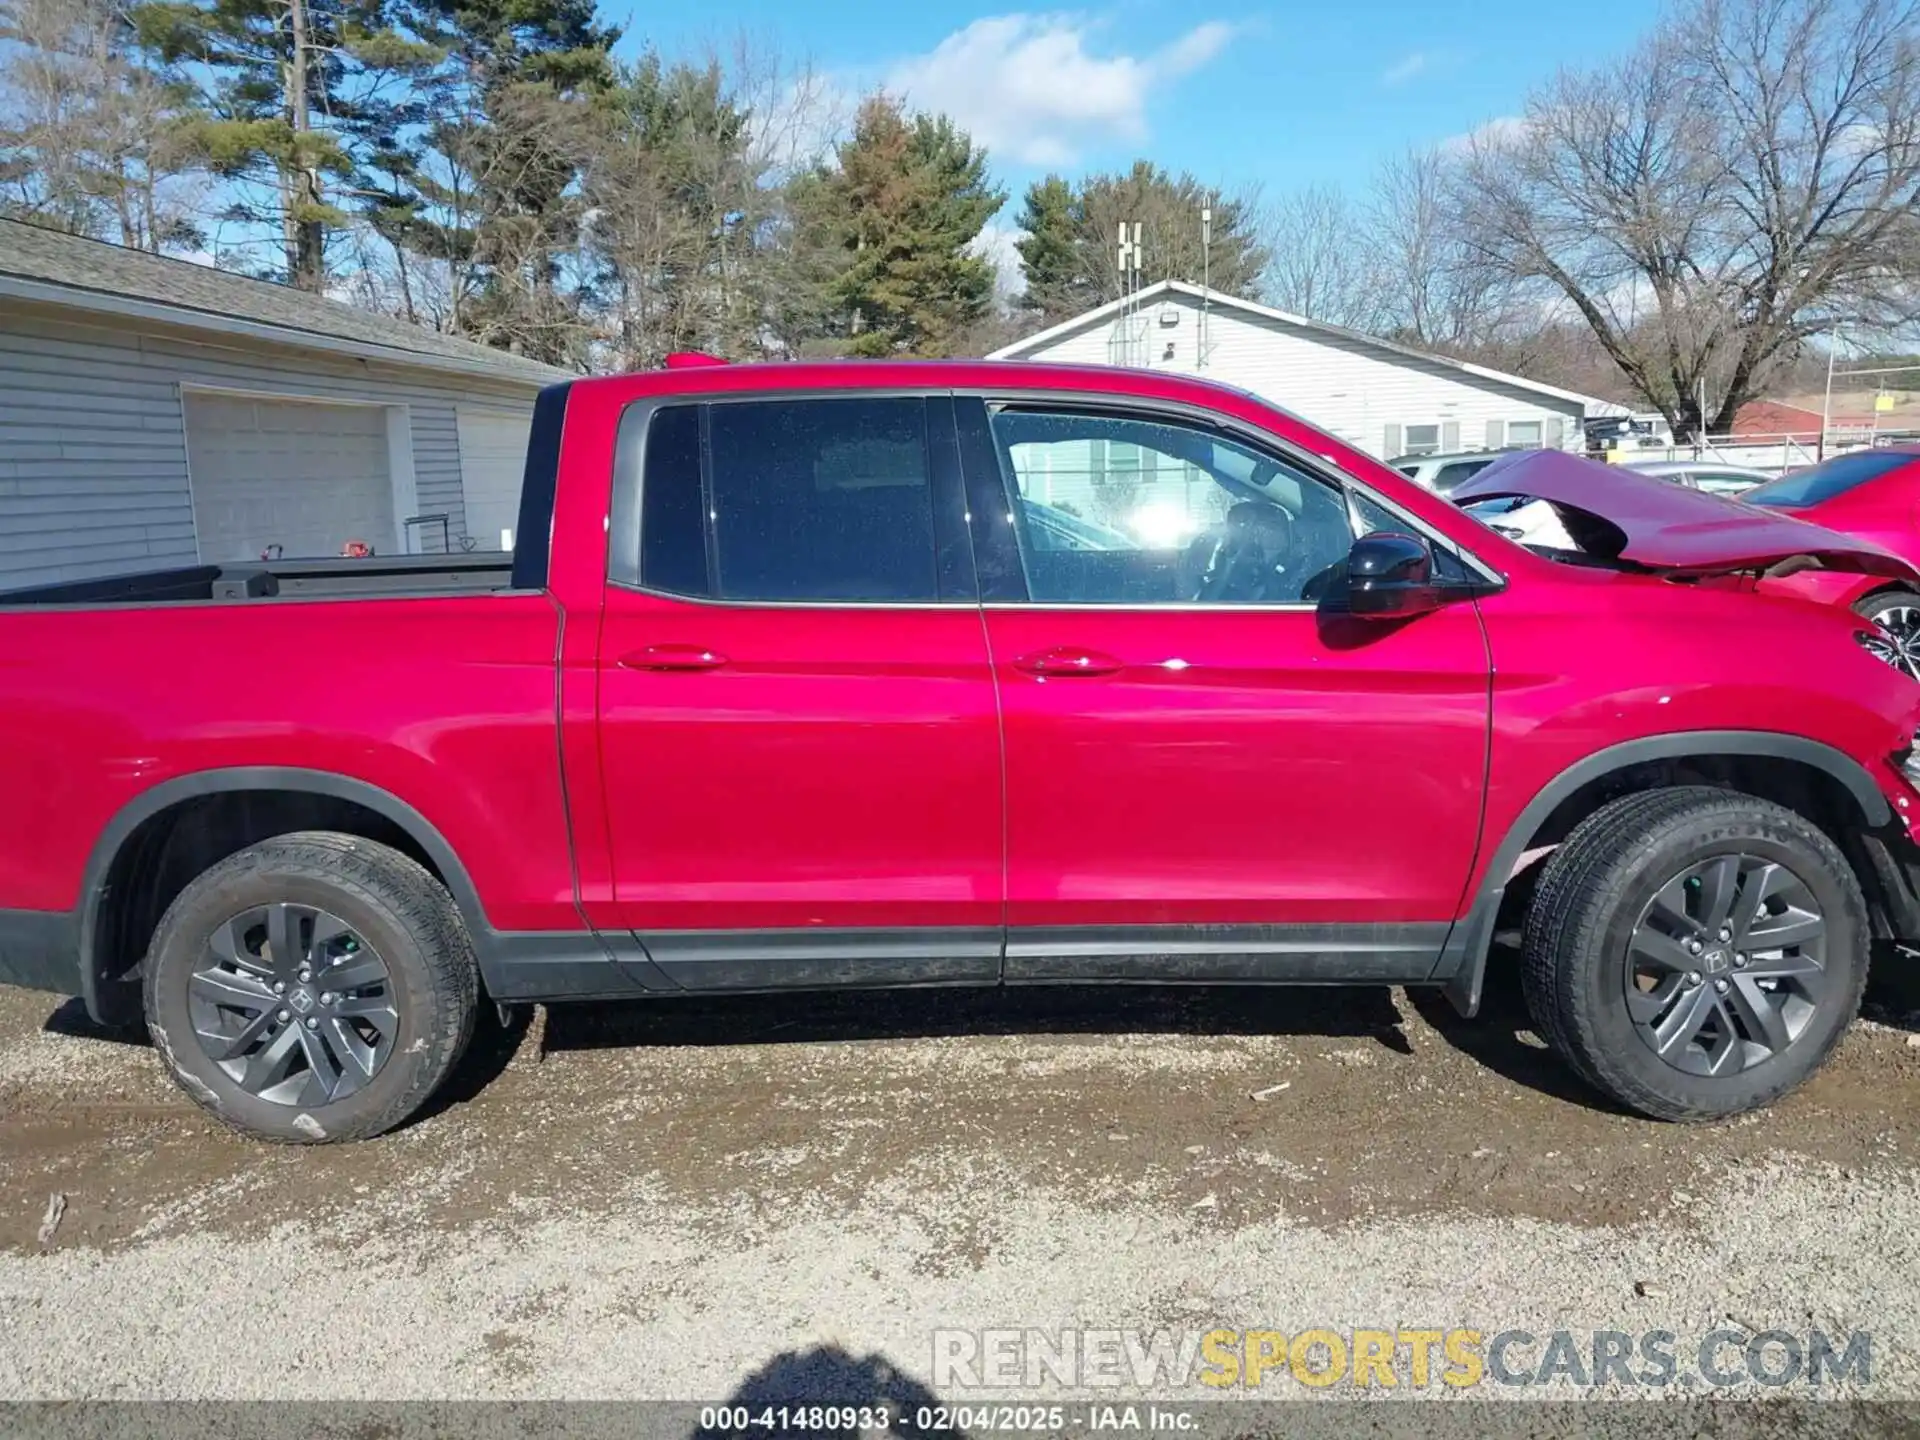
1452;449;1916;578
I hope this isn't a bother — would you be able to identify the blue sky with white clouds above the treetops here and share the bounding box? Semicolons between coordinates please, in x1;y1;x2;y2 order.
625;0;1657;198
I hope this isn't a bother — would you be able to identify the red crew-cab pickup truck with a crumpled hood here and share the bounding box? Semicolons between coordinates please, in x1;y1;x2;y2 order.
0;363;1920;1142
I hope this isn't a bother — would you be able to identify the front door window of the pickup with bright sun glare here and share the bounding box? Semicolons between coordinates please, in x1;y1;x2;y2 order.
993;407;1404;605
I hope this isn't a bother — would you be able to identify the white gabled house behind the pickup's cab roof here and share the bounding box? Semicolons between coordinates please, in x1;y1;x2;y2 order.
993;280;1619;459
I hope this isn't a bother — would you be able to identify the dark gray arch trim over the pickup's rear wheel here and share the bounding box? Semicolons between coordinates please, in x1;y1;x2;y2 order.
77;766;493;1020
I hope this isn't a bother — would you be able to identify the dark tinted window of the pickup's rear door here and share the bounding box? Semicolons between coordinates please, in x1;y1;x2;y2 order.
639;397;939;601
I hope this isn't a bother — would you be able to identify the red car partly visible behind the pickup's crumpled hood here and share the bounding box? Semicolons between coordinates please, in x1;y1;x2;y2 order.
1740;444;1920;680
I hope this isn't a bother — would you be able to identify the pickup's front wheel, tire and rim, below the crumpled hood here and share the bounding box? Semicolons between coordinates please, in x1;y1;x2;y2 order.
1521;785;1868;1119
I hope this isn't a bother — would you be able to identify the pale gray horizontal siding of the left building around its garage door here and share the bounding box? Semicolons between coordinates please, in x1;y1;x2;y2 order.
0;301;534;589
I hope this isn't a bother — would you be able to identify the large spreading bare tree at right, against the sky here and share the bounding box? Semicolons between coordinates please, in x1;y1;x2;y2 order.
1450;0;1920;434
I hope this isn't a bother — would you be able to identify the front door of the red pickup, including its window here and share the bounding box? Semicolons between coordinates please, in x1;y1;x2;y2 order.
960;401;1488;981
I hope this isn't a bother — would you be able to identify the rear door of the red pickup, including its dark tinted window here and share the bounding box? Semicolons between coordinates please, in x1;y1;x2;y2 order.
599;394;1002;989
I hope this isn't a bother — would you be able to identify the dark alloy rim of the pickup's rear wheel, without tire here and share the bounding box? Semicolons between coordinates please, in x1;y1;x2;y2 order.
186;904;399;1106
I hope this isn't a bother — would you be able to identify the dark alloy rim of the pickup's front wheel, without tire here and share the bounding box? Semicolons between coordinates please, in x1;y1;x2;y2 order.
1626;854;1828;1075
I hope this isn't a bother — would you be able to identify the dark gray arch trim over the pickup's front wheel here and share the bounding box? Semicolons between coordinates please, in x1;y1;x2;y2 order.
1432;730;1893;1016
